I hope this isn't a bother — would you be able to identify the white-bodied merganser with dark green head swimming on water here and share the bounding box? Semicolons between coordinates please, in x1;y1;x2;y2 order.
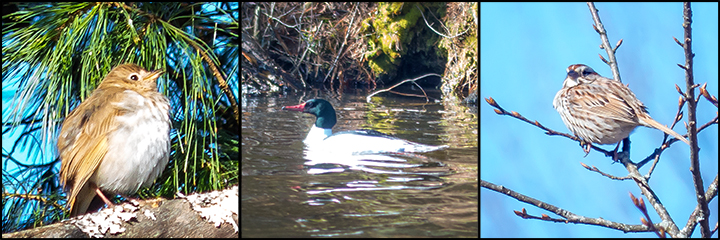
282;98;448;154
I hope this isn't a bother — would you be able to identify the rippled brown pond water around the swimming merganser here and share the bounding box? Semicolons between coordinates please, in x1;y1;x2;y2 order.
241;95;479;237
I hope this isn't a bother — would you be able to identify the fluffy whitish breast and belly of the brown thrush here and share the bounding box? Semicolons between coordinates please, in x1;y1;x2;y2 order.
90;90;170;194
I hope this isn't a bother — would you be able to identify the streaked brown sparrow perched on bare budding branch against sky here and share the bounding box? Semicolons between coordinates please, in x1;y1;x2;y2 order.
553;64;690;152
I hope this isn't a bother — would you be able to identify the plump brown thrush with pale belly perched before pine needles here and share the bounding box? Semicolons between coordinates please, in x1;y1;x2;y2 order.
57;64;170;216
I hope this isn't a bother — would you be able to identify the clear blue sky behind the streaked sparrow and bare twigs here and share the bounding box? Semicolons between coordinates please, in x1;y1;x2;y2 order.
480;2;718;237
